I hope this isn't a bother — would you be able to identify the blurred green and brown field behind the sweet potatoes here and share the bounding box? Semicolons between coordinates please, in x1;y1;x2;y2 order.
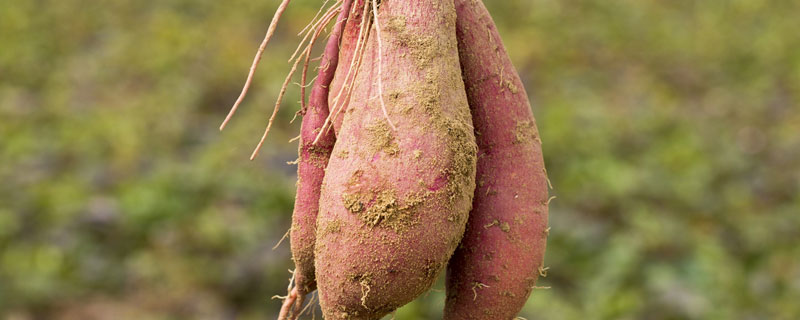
0;0;800;319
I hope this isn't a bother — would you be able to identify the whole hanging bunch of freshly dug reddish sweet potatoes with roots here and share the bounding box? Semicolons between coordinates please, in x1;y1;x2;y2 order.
223;0;549;319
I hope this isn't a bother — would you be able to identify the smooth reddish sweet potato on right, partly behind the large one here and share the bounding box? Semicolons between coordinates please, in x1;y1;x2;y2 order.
444;0;548;319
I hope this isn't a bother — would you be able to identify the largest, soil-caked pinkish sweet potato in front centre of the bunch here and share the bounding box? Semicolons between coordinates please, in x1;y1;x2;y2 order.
315;0;477;319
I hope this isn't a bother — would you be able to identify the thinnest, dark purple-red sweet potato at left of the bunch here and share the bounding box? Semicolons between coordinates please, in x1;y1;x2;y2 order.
290;0;352;295
